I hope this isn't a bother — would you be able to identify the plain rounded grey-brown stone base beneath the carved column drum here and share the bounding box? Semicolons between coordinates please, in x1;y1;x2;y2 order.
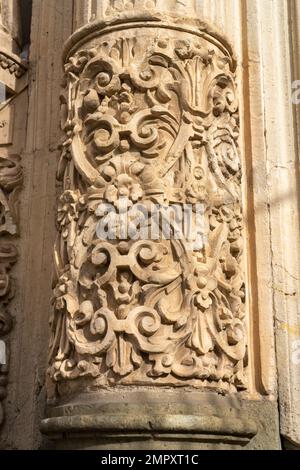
41;390;280;450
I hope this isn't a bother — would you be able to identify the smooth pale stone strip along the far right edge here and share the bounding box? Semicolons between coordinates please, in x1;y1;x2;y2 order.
265;0;300;448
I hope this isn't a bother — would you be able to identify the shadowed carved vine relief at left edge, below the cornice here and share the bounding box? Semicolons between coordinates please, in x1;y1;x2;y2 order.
0;155;23;425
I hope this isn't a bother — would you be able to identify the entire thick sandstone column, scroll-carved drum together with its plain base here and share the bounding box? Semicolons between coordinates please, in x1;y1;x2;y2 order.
42;1;278;448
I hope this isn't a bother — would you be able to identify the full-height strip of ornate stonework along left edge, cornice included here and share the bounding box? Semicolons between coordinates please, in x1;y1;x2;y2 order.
0;0;28;425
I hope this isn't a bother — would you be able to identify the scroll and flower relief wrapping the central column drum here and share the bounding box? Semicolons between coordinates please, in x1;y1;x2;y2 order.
48;24;247;396
